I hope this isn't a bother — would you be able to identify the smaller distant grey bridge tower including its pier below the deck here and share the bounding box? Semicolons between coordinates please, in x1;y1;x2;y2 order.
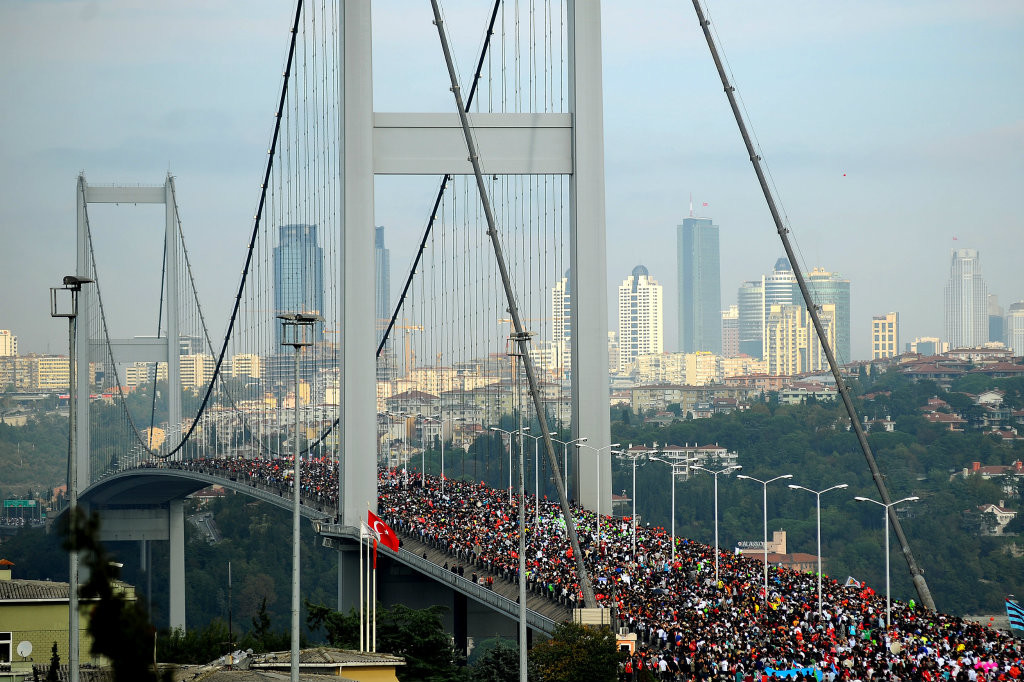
75;174;185;630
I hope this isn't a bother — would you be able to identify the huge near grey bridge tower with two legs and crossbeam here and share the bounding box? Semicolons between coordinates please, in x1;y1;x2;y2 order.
338;0;611;526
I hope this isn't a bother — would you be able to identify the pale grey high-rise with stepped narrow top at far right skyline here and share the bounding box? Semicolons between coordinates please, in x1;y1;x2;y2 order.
945;249;988;348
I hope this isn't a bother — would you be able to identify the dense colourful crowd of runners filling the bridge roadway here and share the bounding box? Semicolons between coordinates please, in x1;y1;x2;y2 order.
155;458;1024;682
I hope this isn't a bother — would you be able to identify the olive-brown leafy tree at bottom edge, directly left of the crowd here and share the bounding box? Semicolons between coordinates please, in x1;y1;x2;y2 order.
529;623;622;682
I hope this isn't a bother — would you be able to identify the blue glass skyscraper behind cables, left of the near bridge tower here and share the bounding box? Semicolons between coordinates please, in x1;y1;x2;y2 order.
273;224;324;350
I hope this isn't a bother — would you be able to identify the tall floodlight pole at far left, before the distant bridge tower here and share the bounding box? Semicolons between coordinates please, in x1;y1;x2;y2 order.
50;274;92;682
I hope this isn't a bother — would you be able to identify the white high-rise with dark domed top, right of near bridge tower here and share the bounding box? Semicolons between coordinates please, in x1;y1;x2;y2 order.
618;265;665;374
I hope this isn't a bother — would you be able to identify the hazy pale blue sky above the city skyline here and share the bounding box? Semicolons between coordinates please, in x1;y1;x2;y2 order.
0;0;1024;358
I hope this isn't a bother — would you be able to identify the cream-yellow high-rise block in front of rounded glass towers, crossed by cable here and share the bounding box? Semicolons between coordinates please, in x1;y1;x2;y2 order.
765;303;836;376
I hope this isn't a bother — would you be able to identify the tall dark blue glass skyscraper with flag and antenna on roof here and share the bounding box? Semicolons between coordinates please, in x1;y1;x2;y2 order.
676;217;722;354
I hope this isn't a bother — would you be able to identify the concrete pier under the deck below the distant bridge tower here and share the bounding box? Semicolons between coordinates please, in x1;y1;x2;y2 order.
96;500;185;630
